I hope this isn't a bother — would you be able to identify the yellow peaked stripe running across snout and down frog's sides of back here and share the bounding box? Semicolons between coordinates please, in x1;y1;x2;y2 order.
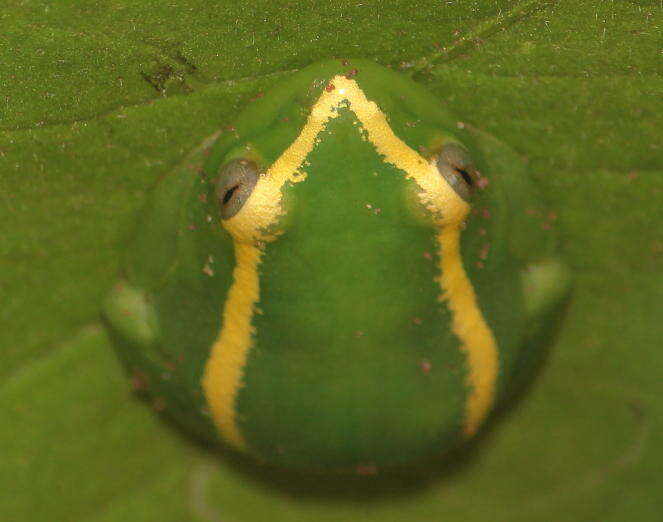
202;76;498;449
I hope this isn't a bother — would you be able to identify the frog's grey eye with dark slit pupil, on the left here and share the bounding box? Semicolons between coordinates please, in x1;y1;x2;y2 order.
216;158;258;219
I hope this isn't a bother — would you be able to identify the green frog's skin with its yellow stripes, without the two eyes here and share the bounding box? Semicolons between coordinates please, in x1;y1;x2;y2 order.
104;60;568;470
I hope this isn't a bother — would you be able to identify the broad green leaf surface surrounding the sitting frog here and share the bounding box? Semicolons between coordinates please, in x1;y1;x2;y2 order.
0;0;663;522
